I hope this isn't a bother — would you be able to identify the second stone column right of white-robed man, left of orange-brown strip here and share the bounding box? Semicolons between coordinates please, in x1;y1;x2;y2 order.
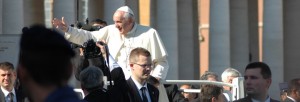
177;0;200;80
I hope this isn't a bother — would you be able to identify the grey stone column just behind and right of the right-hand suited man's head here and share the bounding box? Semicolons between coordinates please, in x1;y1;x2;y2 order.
263;0;285;100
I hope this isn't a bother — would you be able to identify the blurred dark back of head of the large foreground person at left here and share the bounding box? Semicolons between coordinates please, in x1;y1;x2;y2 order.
19;25;75;86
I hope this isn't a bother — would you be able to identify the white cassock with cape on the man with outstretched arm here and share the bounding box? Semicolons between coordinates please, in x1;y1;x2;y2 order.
65;24;169;80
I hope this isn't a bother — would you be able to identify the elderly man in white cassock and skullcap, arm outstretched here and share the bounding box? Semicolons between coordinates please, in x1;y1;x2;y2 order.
52;6;169;80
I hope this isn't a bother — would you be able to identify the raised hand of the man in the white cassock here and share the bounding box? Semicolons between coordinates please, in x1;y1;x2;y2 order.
52;17;68;32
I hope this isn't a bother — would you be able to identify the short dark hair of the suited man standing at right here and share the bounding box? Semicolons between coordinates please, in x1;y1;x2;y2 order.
245;62;272;79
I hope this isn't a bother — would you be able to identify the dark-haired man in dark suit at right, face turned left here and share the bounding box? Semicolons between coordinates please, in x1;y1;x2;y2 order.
235;62;279;102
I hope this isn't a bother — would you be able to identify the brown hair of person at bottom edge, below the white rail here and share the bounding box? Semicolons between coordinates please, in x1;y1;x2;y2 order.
200;84;223;102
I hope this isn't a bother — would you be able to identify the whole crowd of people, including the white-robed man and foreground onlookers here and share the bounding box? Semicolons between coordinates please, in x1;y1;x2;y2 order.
0;6;300;102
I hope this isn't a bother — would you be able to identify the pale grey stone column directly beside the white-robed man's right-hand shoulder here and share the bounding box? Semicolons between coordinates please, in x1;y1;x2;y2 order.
150;0;178;79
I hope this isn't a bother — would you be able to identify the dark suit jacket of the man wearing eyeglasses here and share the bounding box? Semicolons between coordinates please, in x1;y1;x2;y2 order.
127;78;159;102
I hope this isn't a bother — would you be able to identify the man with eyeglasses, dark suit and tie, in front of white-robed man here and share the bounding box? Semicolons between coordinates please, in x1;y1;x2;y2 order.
127;47;159;102
